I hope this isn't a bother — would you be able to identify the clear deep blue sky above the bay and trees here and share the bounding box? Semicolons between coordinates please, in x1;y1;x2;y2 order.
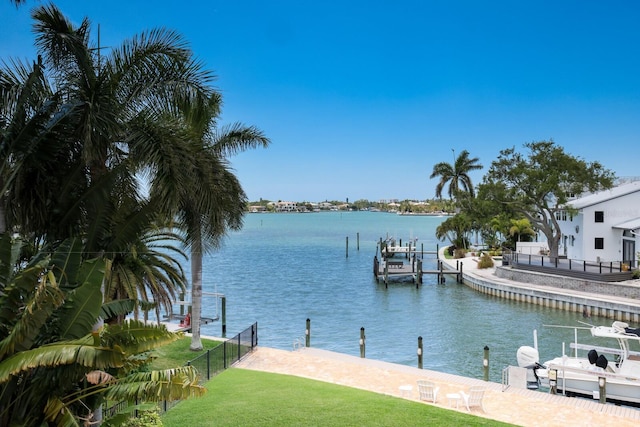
0;0;640;201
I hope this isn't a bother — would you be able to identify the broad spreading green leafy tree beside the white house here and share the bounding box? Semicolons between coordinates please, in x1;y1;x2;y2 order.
482;141;615;257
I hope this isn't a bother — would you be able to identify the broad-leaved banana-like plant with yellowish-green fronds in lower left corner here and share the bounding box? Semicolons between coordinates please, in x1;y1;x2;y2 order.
0;234;204;426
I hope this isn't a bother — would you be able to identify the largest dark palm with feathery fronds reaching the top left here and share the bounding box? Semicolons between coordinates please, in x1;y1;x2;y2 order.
0;5;213;310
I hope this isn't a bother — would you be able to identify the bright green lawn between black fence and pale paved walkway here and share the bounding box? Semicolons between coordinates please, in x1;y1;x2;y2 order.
162;368;509;427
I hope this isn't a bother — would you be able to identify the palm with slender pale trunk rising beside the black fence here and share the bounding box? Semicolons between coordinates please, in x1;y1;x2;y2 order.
151;93;270;350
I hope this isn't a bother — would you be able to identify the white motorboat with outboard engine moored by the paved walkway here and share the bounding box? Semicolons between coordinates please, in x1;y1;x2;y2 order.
517;322;640;406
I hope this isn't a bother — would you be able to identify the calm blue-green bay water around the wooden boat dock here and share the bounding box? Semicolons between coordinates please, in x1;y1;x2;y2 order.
188;212;610;381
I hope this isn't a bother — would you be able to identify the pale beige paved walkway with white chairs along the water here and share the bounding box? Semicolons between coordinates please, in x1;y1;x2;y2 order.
234;347;640;427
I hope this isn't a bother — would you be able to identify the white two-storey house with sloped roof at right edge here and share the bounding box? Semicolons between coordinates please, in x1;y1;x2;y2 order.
556;181;640;267
